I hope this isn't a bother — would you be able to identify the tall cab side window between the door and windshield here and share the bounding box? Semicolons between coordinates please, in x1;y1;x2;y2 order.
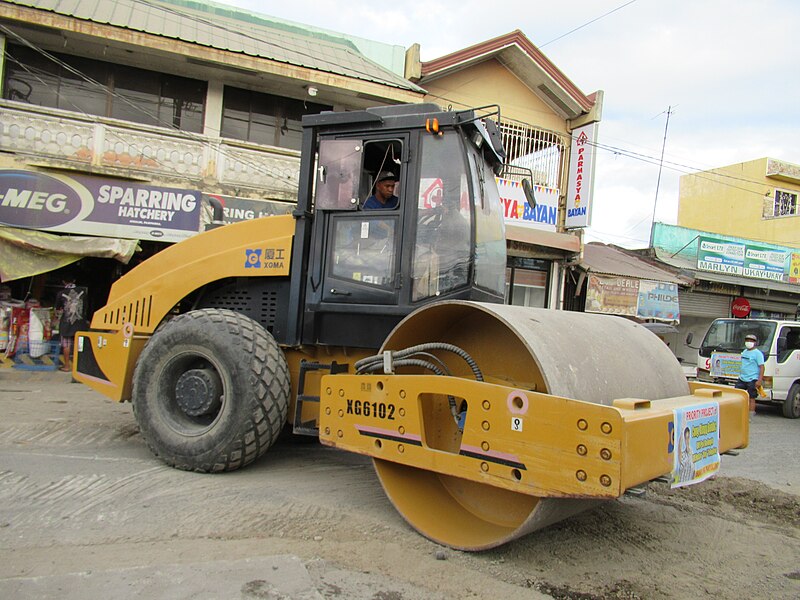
412;132;472;300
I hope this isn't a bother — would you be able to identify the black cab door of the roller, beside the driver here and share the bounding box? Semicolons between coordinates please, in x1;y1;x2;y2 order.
303;133;409;347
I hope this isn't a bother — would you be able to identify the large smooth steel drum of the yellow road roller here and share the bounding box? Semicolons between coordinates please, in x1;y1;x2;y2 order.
374;301;689;550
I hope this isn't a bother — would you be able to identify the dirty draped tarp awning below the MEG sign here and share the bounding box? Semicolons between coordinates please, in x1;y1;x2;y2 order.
0;226;139;281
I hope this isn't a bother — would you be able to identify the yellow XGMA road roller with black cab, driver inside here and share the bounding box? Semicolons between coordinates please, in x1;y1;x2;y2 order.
73;104;748;550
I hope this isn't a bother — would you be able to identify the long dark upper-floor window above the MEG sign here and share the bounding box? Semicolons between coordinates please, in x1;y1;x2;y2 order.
3;44;206;133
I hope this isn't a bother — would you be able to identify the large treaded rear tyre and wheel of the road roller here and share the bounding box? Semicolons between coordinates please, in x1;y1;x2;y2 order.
132;308;290;472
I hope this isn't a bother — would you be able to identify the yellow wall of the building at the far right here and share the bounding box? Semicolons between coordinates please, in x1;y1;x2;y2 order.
678;158;800;246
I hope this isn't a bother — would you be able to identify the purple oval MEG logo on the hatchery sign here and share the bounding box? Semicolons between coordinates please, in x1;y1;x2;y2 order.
0;170;81;227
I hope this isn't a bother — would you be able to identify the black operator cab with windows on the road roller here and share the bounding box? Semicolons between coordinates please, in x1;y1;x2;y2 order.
298;105;506;348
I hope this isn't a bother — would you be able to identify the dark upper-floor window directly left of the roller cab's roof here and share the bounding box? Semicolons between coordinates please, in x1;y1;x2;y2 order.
222;86;332;150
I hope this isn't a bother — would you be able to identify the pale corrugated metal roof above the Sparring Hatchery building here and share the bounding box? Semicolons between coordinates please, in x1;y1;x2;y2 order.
5;0;424;93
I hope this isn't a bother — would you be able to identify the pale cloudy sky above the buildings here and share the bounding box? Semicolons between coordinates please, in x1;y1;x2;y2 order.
211;0;800;248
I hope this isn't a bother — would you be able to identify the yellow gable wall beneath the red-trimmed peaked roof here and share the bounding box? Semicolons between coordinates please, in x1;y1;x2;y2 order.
424;59;567;133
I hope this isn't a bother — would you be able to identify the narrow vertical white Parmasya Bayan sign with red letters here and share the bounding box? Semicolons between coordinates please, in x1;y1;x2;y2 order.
566;123;597;229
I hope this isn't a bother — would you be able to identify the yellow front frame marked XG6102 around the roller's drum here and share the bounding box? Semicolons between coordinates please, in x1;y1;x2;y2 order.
320;375;748;498
